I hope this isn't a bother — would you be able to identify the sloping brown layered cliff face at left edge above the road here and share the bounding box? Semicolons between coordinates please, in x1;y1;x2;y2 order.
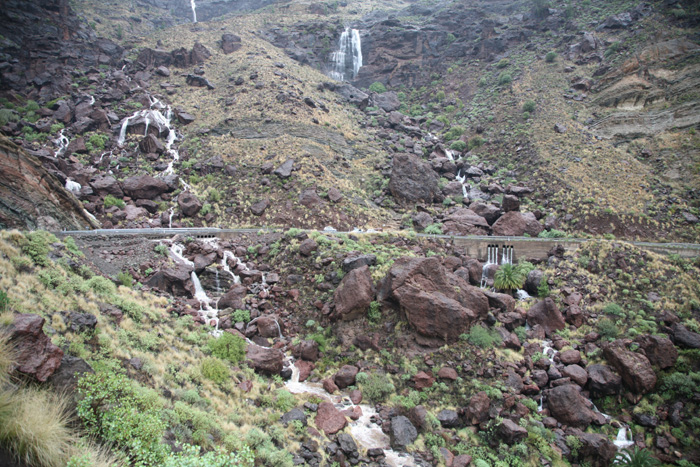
0;137;96;230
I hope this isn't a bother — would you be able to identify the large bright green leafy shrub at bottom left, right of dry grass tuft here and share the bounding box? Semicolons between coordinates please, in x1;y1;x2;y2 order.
77;371;170;467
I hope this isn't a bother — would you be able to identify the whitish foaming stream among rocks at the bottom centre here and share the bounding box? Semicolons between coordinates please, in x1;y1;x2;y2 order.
284;357;416;467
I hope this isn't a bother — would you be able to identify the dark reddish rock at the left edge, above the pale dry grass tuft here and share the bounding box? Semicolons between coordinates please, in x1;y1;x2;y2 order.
9;314;63;383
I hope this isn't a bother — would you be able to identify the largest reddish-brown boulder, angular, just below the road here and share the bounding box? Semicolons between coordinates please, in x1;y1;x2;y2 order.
378;257;489;341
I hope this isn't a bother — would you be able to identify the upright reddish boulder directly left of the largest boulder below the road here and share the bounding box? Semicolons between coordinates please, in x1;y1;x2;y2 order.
333;266;376;321
